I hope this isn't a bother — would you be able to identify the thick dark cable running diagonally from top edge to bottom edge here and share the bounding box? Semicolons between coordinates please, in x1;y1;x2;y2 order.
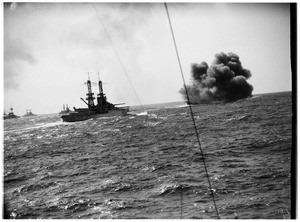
164;2;220;219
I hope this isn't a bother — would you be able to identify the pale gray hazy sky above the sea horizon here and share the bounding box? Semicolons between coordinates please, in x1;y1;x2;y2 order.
4;3;291;115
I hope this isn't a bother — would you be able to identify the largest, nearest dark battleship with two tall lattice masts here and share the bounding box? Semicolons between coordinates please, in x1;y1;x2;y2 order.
61;76;129;122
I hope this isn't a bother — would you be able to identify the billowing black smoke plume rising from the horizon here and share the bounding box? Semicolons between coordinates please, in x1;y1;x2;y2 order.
179;52;253;104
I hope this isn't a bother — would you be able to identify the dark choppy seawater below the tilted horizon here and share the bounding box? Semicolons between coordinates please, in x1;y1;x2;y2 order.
4;92;292;219
